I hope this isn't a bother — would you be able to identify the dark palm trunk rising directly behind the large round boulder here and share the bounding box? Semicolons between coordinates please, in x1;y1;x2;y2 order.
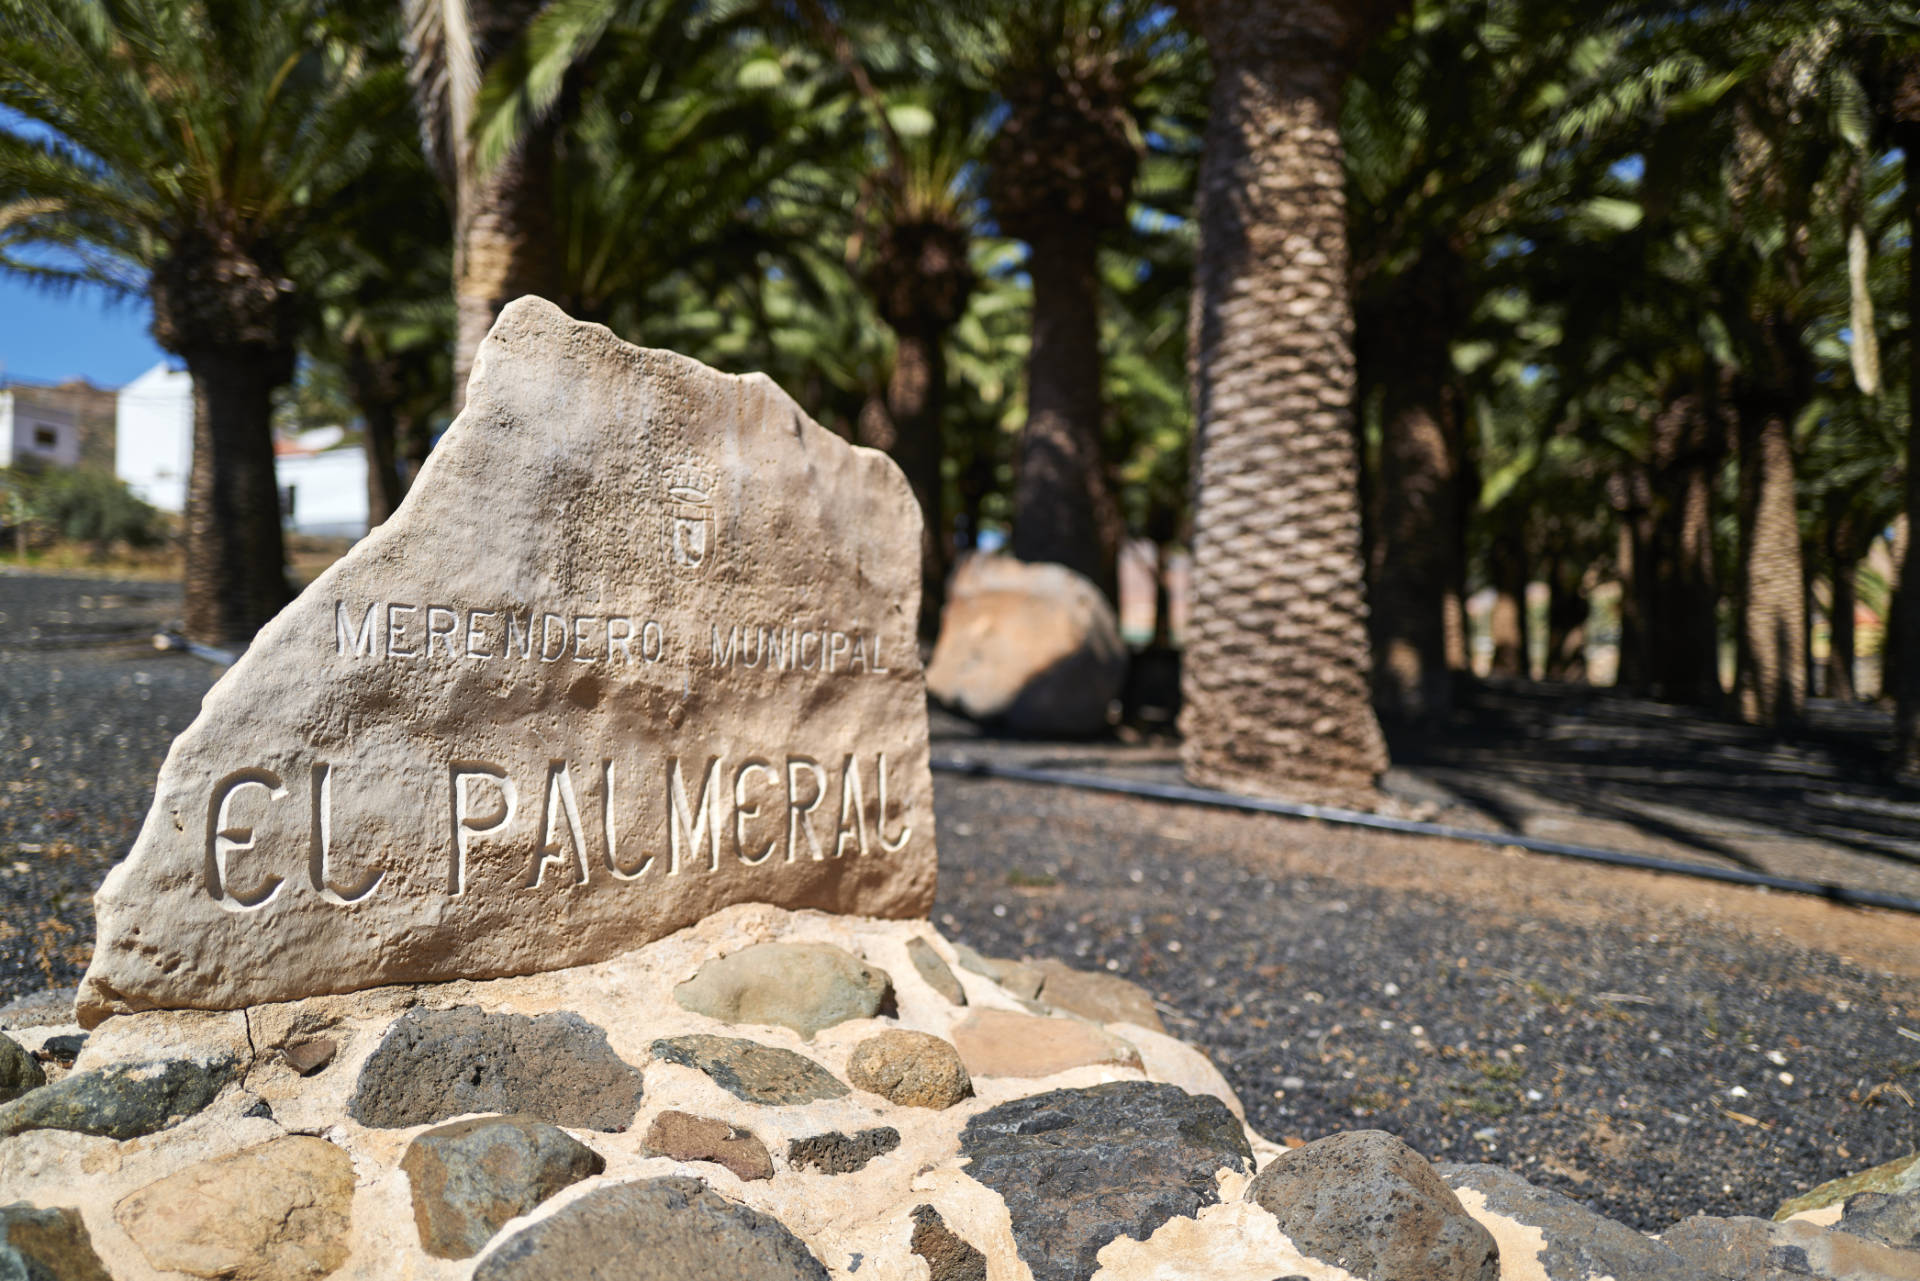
1014;229;1119;601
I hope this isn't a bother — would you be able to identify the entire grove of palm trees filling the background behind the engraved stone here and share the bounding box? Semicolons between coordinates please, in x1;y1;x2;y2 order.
0;0;1920;799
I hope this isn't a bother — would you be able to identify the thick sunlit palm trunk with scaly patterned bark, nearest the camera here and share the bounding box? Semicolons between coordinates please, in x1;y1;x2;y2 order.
1181;0;1396;799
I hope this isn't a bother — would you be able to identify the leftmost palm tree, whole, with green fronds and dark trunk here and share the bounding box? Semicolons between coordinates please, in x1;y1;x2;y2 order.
0;0;405;643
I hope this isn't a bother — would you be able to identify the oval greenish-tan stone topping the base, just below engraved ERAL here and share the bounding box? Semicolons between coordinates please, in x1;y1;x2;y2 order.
674;943;893;1039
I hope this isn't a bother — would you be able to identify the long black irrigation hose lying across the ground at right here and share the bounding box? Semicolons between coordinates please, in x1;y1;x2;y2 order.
933;757;1920;914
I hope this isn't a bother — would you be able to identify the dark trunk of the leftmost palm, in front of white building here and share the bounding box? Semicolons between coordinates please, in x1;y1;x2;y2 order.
184;348;292;645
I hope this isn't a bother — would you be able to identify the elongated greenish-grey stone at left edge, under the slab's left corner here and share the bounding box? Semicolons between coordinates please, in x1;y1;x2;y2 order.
0;1058;232;1139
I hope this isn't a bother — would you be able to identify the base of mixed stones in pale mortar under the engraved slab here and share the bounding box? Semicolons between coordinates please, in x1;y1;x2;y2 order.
0;905;1920;1281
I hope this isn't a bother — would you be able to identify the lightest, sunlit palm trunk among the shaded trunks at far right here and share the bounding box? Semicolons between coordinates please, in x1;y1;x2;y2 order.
1738;405;1807;730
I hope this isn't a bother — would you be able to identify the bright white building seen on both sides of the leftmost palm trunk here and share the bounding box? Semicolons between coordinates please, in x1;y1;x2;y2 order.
115;363;367;538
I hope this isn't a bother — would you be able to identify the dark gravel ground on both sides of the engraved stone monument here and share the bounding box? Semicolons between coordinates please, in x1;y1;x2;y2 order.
0;576;1920;1229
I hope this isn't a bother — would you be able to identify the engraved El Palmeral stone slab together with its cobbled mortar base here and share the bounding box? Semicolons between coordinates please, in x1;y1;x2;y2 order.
0;300;1812;1281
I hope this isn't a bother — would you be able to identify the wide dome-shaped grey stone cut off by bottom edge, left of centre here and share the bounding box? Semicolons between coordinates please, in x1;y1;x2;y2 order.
474;1177;828;1281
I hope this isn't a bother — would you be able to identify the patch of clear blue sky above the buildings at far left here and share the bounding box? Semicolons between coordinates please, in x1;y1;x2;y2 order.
0;277;167;386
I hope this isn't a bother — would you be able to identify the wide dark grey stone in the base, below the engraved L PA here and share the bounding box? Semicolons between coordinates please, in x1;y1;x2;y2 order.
348;1004;641;1129
